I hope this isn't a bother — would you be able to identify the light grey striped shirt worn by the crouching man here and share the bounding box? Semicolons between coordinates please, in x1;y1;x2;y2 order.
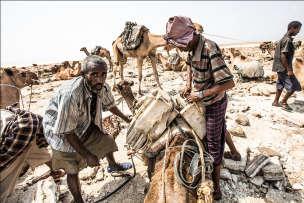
43;76;115;152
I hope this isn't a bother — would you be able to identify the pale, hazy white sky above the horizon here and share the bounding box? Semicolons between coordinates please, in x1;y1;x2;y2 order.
1;1;304;67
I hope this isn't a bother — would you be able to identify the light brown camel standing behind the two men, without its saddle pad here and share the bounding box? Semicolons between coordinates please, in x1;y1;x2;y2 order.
112;30;167;94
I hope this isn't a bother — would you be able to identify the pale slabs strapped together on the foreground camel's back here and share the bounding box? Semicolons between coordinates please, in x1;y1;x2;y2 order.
126;90;206;156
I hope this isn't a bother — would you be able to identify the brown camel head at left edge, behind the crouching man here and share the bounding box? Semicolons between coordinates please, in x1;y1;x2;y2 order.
1;68;39;88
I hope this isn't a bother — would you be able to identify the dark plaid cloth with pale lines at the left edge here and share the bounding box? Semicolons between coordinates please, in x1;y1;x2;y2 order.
0;106;48;171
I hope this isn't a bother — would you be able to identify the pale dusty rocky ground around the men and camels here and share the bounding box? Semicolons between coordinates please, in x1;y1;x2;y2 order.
5;44;304;202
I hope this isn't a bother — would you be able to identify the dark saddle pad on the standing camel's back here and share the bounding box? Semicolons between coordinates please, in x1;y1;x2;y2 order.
120;21;149;50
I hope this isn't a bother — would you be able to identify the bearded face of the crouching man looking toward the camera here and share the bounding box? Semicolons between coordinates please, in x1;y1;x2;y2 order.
85;67;108;91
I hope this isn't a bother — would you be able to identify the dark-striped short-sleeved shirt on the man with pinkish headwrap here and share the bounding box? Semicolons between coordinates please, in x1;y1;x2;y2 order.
188;35;233;106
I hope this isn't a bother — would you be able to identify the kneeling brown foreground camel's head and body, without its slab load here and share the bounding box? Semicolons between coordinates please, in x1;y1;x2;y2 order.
115;80;197;203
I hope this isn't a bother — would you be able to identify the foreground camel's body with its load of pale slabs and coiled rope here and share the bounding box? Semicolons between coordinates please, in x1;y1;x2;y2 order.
123;87;213;203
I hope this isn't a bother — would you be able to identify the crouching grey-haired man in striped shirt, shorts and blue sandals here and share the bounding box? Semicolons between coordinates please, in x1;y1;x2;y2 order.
43;55;132;203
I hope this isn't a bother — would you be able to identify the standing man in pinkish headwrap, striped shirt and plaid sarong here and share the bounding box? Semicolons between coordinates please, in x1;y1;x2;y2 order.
165;16;234;200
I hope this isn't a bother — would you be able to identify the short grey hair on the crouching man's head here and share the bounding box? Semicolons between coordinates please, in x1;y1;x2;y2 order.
81;55;107;74
